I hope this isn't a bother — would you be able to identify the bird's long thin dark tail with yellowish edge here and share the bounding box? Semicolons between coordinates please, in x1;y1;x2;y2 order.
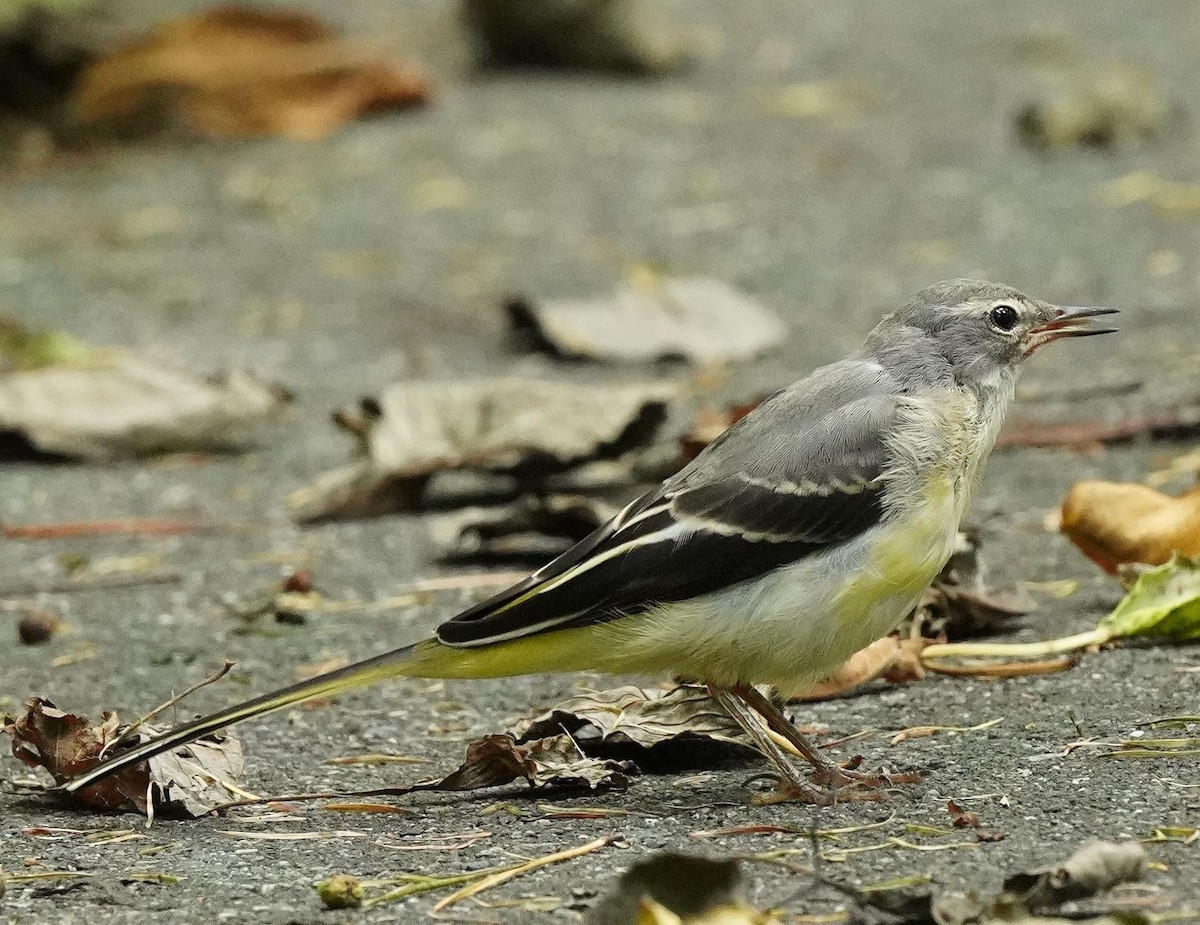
61;642;427;793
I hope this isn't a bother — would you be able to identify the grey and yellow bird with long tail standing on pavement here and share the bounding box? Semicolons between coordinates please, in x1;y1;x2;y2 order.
62;280;1116;805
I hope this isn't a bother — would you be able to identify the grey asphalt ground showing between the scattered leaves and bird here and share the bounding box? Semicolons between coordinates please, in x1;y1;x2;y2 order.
0;0;1200;923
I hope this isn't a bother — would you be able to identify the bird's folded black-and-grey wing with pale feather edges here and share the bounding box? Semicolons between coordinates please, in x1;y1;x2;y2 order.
437;371;895;647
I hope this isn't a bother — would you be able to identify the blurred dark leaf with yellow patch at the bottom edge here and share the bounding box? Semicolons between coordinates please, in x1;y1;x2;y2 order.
583;852;778;925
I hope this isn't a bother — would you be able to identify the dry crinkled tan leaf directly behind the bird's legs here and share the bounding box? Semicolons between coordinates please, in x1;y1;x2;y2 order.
509;685;752;755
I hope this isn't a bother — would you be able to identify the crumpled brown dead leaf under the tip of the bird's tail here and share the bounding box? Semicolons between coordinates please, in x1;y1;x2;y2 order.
4;697;244;816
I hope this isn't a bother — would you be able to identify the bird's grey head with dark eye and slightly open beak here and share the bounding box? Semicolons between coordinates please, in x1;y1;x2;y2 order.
872;280;1116;389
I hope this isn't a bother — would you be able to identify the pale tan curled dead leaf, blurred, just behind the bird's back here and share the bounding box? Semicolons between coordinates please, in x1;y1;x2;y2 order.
289;378;677;521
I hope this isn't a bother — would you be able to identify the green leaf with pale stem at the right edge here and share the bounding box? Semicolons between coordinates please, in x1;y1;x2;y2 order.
1098;554;1200;642
